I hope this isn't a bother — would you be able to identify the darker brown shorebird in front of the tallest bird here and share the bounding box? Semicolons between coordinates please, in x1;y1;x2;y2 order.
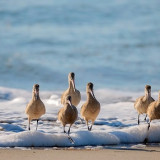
58;95;78;142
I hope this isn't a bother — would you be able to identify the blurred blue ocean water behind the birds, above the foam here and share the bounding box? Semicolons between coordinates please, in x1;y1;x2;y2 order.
0;0;160;91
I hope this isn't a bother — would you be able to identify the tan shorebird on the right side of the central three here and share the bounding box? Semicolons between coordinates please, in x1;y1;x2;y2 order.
81;82;100;131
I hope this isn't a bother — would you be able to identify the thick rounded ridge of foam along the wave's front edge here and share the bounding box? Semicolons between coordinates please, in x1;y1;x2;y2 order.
0;125;160;147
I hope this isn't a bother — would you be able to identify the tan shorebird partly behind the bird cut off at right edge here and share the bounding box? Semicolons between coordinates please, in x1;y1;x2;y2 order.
134;85;154;125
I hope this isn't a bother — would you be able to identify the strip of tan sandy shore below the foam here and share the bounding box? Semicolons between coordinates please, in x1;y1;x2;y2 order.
0;147;160;160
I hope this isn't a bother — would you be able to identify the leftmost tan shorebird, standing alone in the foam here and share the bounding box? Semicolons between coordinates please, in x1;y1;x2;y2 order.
25;84;46;130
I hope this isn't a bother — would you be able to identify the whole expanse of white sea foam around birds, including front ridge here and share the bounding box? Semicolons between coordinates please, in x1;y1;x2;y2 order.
0;87;160;147
